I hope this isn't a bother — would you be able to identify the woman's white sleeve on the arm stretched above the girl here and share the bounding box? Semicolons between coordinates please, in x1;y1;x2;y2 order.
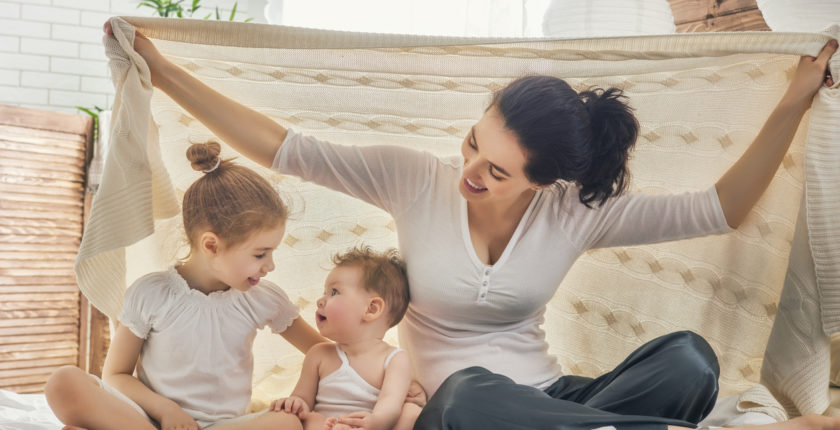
272;130;437;217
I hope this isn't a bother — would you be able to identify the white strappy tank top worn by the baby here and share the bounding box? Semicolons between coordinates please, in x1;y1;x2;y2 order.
313;345;402;417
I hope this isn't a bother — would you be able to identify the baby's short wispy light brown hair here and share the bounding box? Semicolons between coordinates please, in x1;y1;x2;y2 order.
333;246;409;327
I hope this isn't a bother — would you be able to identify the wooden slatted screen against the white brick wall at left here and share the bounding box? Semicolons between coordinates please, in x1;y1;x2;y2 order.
0;105;93;393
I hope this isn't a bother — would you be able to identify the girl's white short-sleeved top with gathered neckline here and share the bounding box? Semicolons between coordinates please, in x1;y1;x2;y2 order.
118;267;298;422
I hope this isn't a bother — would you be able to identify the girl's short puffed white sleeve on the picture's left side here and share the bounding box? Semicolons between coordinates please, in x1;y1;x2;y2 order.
117;273;169;339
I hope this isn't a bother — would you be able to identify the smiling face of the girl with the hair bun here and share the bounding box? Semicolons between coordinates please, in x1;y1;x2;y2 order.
210;223;286;291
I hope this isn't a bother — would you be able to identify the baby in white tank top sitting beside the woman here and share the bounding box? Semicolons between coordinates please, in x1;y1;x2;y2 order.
270;248;420;430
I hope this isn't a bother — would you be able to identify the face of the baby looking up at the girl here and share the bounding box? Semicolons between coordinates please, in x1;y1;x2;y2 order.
315;265;374;342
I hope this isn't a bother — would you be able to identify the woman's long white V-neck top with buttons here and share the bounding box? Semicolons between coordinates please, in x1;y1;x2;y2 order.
273;130;731;395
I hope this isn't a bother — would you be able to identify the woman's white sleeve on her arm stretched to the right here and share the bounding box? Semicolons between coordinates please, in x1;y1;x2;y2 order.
576;186;733;250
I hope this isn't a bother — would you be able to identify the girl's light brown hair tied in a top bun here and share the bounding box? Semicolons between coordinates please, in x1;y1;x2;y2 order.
182;141;288;248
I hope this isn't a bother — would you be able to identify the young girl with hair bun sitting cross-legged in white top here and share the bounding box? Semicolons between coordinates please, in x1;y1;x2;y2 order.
46;142;324;430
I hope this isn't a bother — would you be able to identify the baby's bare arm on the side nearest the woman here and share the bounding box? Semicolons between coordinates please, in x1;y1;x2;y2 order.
335;351;411;430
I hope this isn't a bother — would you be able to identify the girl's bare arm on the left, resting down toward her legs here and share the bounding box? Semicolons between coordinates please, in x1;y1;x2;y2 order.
102;325;196;428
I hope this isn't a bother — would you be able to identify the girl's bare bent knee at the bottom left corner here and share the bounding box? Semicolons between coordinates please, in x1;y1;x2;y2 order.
44;366;155;430
